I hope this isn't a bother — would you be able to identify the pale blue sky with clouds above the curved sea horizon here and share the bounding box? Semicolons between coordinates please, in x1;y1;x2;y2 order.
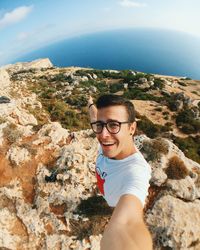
0;0;200;65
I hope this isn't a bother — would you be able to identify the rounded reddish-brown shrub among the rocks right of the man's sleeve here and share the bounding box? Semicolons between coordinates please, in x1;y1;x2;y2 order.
165;156;189;180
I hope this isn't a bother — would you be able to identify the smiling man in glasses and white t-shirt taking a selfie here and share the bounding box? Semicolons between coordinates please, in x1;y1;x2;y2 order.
88;95;152;250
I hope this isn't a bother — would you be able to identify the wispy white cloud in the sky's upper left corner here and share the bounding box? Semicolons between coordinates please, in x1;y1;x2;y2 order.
0;6;33;28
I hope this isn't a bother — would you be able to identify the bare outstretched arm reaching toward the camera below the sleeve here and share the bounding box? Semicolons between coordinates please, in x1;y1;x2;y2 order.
101;194;152;250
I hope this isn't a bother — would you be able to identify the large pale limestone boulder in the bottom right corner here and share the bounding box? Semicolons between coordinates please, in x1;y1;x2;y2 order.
146;195;200;249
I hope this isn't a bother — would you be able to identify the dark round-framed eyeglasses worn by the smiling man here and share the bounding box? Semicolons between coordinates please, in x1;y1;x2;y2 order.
90;121;131;134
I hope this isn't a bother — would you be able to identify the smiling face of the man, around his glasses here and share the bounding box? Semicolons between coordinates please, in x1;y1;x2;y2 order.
96;105;136;160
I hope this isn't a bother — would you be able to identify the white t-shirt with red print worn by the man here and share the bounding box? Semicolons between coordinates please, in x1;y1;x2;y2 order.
96;148;151;207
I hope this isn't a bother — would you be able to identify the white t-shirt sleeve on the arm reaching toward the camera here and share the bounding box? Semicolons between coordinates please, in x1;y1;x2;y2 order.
120;164;151;206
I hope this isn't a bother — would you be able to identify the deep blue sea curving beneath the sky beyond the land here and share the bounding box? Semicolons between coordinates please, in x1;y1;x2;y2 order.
13;28;200;80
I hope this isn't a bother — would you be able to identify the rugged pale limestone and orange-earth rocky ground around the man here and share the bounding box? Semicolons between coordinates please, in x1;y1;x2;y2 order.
0;59;200;250
